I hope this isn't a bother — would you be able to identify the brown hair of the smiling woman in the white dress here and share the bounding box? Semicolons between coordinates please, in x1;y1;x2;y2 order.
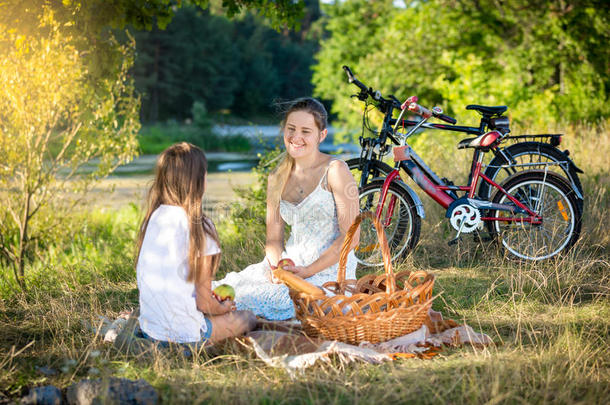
268;97;328;205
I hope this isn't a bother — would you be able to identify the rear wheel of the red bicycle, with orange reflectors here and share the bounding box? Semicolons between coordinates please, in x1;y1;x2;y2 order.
488;170;581;260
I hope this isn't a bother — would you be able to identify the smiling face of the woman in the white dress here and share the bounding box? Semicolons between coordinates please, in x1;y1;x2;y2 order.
284;111;326;159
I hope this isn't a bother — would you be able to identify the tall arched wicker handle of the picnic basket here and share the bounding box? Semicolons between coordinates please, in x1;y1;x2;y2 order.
337;211;396;294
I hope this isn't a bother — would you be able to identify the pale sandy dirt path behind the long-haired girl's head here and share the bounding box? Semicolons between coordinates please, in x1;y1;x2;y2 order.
87;172;256;211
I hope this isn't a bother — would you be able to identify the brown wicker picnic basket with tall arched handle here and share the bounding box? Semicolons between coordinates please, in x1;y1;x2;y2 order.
280;212;434;344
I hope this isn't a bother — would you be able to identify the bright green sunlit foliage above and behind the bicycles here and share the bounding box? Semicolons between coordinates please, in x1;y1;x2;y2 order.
313;0;610;129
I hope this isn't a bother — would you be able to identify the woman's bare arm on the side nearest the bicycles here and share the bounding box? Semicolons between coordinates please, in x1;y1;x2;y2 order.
285;161;360;278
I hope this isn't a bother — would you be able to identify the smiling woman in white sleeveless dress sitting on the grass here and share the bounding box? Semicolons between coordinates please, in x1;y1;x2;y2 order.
215;98;359;320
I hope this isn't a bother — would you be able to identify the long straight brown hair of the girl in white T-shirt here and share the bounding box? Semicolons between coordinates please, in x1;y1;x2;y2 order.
136;142;220;283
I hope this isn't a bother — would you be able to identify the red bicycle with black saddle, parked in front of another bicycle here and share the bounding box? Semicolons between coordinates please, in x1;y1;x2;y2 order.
356;97;582;266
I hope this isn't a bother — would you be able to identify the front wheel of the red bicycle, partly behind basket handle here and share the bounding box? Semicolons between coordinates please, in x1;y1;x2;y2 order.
355;180;421;266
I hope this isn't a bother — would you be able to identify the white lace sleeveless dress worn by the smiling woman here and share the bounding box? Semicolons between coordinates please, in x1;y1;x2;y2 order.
212;163;357;320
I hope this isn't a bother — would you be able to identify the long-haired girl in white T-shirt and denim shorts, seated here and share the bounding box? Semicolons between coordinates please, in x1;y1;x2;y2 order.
136;142;256;343
